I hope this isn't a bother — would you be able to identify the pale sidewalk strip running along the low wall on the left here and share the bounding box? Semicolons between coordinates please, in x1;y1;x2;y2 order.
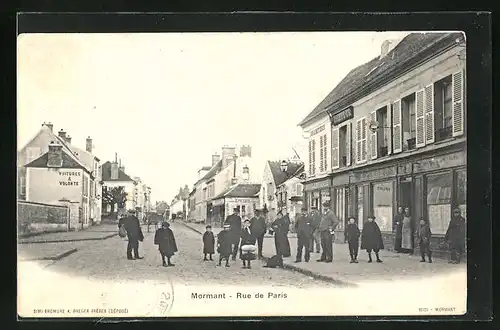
17;224;118;244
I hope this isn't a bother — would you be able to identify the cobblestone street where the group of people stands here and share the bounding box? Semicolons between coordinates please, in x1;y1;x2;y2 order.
20;223;333;288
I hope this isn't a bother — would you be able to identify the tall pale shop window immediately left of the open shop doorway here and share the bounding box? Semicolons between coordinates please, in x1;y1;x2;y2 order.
372;181;393;232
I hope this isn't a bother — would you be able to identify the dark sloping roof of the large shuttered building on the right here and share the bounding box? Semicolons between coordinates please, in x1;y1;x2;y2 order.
299;33;461;126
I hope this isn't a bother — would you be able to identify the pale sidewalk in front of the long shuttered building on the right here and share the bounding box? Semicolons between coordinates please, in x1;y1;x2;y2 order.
184;223;467;285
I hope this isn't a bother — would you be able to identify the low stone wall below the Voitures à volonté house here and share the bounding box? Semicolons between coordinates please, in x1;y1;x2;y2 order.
17;201;68;236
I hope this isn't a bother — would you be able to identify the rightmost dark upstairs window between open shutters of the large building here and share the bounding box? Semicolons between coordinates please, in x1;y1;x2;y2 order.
434;75;453;141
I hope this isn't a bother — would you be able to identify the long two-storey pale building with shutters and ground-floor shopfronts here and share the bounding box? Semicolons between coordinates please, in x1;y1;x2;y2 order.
300;33;467;252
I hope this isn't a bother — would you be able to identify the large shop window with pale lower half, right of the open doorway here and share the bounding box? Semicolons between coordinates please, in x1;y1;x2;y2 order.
426;173;453;235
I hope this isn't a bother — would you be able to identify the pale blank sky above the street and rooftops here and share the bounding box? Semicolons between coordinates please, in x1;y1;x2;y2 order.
17;32;408;201
